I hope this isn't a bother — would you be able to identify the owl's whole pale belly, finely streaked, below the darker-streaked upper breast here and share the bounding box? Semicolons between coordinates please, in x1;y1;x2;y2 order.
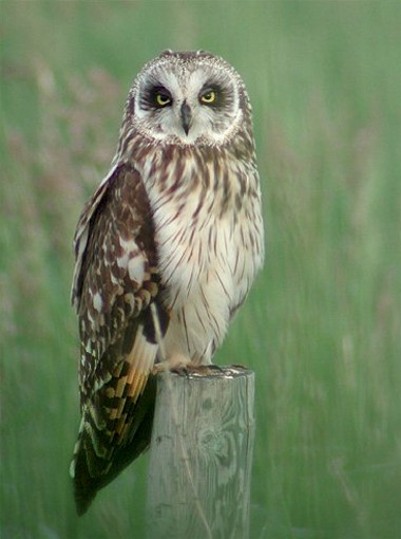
149;160;263;364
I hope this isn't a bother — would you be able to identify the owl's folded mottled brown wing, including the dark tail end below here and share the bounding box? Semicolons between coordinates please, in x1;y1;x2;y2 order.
71;164;168;514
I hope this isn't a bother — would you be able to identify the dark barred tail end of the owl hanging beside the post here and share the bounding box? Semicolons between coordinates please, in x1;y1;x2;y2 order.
70;374;156;515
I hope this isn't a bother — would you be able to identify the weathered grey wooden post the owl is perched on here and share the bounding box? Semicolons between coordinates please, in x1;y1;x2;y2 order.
147;367;255;539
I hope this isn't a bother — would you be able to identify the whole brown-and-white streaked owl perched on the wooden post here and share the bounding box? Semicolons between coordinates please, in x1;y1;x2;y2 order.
70;50;264;514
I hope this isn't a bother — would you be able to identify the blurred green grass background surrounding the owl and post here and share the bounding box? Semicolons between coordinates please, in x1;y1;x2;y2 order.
0;0;401;539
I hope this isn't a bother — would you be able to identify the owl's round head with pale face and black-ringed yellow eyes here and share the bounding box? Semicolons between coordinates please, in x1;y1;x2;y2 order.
128;51;247;145
